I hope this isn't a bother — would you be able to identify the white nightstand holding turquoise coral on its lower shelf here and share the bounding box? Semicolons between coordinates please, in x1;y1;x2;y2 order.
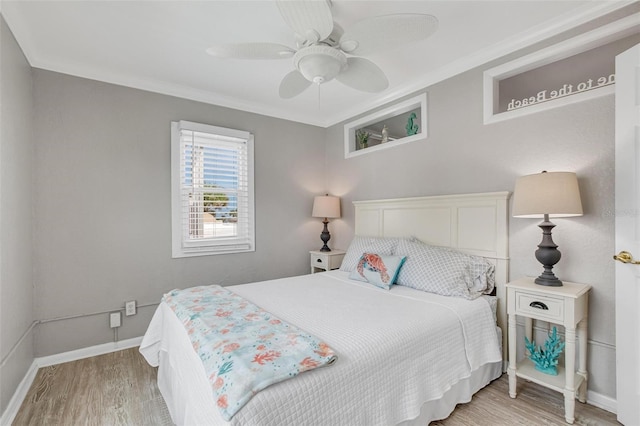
507;278;591;423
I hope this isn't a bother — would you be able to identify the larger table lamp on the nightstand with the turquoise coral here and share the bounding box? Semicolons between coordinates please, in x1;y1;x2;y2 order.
513;171;582;287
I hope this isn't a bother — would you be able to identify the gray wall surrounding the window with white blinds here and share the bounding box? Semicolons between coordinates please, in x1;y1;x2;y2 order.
34;69;326;356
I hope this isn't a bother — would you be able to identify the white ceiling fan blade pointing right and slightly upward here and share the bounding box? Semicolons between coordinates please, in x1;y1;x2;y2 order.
340;13;438;55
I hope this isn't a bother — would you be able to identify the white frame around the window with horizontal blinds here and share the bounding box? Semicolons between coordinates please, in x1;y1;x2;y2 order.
171;120;255;258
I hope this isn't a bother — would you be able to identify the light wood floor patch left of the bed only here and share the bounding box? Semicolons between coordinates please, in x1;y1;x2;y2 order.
13;348;172;426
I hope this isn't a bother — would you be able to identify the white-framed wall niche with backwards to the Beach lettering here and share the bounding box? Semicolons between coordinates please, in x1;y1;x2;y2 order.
484;13;640;124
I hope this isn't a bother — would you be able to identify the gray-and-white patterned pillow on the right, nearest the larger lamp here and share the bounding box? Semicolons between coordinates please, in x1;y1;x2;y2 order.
396;239;494;299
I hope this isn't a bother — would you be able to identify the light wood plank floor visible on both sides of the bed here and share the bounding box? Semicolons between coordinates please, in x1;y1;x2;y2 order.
13;348;619;426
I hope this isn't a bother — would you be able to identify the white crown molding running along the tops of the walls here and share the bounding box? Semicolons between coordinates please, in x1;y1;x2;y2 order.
0;0;637;128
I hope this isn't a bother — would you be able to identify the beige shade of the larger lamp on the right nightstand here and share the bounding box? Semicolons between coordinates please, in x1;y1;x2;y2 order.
513;172;582;218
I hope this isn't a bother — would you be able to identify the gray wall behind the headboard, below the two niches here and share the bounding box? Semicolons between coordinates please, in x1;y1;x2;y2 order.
327;51;615;398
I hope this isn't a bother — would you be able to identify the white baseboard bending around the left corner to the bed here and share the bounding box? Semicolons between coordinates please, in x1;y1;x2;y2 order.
0;337;142;426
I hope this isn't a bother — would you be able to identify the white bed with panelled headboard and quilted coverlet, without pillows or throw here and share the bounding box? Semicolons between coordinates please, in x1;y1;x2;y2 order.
140;192;509;426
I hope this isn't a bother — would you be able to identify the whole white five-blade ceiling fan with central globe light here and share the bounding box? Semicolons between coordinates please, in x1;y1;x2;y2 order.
207;0;438;99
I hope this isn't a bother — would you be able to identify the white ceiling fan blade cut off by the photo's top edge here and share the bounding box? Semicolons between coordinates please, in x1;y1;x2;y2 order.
276;0;333;43
